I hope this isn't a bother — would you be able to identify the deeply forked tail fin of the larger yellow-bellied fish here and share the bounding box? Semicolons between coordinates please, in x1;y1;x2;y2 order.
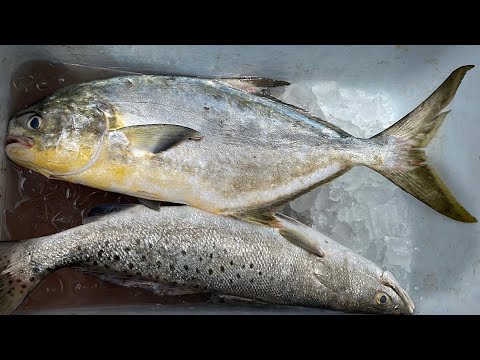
367;65;477;223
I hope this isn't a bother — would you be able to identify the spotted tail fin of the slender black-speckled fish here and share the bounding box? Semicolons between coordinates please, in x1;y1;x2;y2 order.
0;241;43;315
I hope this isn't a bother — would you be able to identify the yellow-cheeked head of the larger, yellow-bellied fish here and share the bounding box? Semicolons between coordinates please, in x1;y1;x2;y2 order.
5;87;106;177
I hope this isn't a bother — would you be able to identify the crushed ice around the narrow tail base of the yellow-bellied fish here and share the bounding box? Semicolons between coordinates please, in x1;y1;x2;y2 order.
279;81;415;291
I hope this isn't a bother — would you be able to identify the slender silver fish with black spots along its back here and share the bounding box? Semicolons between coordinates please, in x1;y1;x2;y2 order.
0;205;414;314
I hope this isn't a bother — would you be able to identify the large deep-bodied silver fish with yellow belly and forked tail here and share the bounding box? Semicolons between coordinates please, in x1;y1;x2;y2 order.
6;66;476;222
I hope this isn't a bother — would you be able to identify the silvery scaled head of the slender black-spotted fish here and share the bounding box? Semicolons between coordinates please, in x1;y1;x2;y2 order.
314;250;415;314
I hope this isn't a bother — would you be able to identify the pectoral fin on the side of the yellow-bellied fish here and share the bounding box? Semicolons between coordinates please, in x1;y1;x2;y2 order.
116;124;202;154
